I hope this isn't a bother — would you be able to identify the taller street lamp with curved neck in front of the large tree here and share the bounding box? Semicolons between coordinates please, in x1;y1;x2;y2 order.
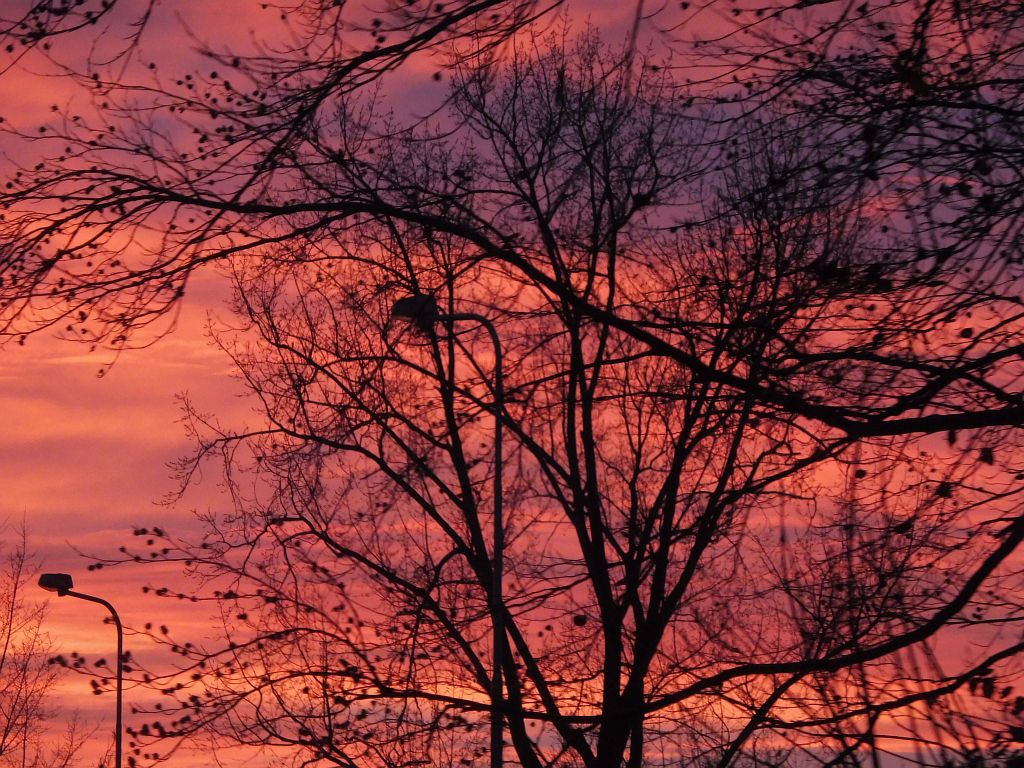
391;294;505;768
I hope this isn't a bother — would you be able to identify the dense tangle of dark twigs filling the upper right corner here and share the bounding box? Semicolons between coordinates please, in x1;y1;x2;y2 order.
700;0;1024;290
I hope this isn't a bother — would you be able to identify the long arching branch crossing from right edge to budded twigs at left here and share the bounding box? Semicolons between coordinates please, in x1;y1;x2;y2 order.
0;3;1024;434
